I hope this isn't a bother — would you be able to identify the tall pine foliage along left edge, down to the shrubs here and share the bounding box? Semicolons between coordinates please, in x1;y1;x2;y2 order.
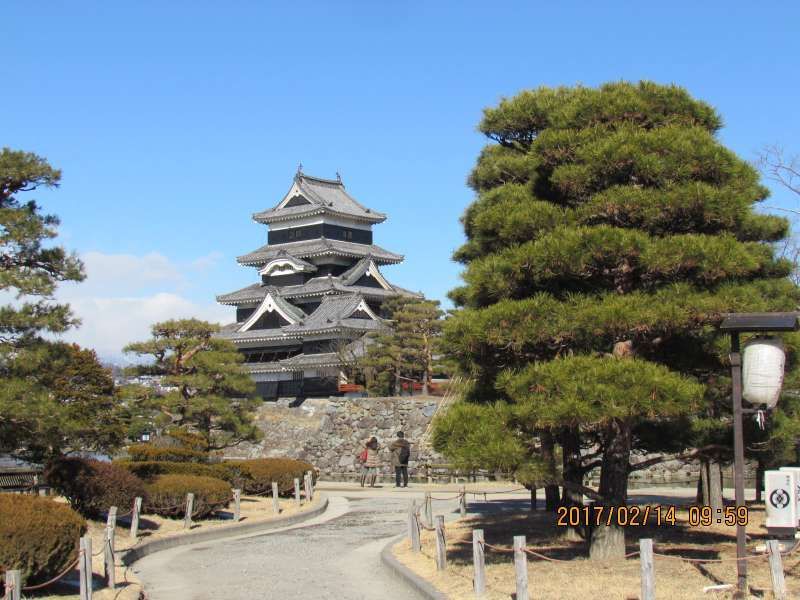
0;148;123;461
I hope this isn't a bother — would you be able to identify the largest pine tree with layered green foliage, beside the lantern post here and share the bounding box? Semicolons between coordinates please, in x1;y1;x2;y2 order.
438;82;799;557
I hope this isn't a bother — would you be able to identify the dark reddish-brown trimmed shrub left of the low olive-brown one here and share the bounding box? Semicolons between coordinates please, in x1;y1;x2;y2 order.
44;457;146;518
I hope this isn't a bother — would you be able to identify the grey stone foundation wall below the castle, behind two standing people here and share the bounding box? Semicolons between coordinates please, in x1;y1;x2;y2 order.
228;396;445;475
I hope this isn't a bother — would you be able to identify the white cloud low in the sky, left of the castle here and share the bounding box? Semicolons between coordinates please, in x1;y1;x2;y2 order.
56;252;232;361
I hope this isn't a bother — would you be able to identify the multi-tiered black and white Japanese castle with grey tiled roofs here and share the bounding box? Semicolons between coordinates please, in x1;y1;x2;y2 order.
217;170;421;399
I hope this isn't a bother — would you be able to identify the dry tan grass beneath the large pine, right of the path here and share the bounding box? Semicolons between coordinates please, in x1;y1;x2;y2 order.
394;506;800;600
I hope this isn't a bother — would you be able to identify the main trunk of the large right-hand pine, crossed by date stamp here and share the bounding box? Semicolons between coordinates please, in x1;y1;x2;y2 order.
589;419;631;560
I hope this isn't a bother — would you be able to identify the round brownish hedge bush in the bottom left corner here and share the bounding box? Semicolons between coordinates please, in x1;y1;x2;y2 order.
0;494;86;585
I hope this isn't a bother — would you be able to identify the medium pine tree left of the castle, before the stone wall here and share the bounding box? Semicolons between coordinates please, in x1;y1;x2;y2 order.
125;319;260;450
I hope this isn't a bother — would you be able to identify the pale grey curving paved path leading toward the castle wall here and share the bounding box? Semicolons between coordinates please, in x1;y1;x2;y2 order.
133;488;456;600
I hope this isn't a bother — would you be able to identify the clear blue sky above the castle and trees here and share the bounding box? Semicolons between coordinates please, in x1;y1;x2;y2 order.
0;0;800;355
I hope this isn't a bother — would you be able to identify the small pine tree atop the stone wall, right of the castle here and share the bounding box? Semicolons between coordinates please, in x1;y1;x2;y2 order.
359;297;444;395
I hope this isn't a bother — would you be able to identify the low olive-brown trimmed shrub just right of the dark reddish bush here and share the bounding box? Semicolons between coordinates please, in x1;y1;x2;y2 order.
145;475;232;519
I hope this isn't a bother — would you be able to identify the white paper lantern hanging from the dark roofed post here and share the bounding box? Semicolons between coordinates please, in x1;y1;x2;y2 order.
742;338;786;408
